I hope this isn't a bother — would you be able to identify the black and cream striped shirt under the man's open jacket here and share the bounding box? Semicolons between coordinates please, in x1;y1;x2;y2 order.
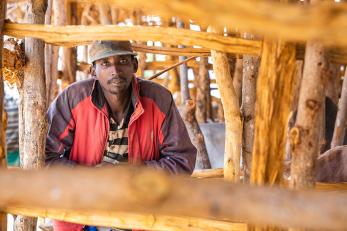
103;102;134;164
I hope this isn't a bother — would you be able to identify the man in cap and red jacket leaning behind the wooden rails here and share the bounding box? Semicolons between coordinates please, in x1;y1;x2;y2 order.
46;41;196;231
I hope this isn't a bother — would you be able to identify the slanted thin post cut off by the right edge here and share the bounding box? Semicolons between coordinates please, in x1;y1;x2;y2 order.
331;70;347;148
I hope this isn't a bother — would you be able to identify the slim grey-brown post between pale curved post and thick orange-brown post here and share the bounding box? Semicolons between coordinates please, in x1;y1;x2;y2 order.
241;55;259;182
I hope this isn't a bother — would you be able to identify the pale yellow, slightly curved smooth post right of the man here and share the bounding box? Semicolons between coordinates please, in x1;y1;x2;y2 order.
209;27;242;182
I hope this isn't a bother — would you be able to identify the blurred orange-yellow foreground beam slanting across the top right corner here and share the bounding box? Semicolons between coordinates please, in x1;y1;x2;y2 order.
72;0;347;46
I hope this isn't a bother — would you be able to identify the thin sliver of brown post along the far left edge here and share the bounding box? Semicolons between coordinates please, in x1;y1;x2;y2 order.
0;0;7;230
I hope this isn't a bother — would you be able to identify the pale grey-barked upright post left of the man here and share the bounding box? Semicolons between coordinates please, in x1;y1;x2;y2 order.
15;0;47;231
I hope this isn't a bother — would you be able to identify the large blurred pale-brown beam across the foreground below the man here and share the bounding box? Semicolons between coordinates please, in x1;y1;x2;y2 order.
0;167;347;230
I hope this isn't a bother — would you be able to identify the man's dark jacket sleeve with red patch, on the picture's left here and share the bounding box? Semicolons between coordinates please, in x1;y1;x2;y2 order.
45;90;76;166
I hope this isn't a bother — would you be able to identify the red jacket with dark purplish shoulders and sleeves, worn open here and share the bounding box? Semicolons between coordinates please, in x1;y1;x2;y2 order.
46;78;196;231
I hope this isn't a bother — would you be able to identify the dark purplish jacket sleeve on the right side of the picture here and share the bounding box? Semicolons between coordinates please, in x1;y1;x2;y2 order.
145;97;197;174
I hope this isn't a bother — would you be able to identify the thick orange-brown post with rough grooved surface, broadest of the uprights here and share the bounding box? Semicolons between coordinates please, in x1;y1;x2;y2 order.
251;39;296;185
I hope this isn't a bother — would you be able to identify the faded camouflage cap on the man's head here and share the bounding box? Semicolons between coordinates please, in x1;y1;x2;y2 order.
89;41;137;63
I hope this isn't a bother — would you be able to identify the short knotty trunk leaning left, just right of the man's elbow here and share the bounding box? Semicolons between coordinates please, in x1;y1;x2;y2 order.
182;100;211;169
